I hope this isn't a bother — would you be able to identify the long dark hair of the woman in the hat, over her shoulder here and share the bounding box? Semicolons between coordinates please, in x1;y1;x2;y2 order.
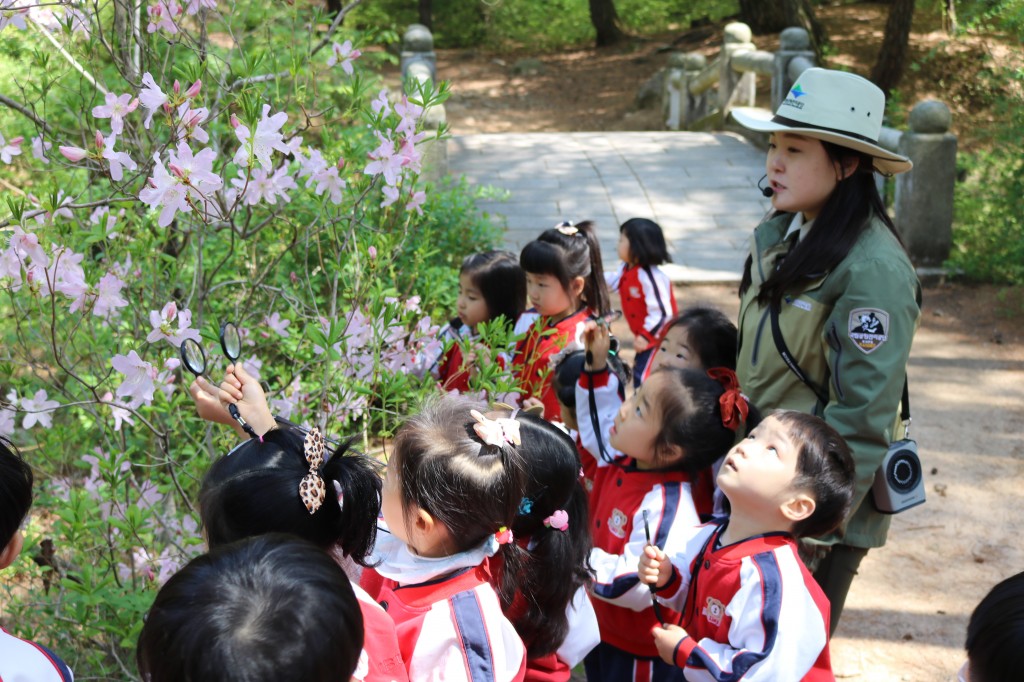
739;140;903;306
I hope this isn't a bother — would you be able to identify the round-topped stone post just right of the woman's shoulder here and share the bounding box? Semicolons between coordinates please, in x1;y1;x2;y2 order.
894;99;956;268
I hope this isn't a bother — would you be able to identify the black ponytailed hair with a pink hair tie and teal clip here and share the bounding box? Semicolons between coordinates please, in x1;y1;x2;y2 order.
503;405;593;658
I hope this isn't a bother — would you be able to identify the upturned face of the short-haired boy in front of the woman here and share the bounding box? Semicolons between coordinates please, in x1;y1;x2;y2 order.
718;417;800;513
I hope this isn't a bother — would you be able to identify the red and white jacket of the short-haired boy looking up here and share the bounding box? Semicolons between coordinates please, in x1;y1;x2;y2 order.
657;520;836;682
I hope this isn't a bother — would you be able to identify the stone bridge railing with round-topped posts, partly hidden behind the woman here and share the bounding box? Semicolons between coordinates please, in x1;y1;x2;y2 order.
662;23;956;271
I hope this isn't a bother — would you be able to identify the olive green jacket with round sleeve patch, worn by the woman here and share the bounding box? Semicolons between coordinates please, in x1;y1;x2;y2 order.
736;214;921;548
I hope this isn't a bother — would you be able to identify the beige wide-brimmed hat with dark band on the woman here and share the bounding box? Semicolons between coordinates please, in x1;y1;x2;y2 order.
732;69;913;175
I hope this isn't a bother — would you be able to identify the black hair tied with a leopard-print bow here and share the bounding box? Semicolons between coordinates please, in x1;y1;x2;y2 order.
200;424;381;565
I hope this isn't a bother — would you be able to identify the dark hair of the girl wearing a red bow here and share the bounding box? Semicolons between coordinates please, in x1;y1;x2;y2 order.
650;367;761;473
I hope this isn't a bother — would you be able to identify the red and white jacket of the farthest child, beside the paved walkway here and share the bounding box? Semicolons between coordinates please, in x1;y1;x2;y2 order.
605;263;677;345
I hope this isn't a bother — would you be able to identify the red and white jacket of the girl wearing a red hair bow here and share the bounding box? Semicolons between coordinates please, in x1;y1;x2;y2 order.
577;370;711;657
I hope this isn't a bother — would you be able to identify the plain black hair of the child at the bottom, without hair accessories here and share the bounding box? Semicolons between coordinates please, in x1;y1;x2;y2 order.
135;534;364;682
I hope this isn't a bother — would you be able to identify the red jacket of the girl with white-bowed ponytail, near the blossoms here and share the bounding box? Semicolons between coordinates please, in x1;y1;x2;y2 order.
512;307;591;422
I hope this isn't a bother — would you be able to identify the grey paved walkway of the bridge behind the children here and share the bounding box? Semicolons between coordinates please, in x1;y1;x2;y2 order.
449;132;771;282
